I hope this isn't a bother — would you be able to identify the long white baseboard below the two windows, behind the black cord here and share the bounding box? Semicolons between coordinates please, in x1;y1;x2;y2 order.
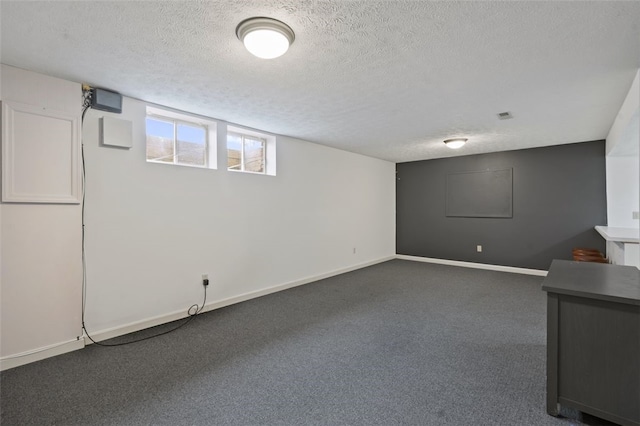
84;256;396;345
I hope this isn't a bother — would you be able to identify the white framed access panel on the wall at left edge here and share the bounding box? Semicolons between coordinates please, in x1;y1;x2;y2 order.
2;101;80;204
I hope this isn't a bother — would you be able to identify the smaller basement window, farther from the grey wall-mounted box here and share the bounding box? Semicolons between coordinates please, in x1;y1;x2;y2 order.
227;126;276;176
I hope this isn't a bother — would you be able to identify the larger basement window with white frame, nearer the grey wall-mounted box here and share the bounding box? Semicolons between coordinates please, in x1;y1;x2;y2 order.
145;107;216;169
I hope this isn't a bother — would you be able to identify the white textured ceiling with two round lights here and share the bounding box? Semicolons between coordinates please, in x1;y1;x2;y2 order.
0;0;640;162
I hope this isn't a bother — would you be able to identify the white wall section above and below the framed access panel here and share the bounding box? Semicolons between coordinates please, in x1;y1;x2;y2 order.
0;65;82;366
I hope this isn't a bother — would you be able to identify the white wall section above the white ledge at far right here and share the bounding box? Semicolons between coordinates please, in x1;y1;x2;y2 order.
606;70;640;228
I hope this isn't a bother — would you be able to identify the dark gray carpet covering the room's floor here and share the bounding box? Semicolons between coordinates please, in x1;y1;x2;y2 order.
0;260;608;426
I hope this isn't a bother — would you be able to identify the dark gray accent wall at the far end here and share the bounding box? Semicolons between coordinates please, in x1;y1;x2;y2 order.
396;140;607;270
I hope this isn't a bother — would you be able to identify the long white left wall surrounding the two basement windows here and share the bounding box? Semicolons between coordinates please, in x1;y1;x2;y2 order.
1;65;395;366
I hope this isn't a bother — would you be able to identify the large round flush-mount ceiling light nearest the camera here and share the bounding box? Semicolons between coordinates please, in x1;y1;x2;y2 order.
236;17;295;59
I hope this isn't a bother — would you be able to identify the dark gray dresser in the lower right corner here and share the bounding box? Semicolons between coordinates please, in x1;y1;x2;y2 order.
542;260;640;426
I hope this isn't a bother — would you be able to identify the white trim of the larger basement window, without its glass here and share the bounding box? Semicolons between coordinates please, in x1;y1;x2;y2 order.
145;106;218;169
